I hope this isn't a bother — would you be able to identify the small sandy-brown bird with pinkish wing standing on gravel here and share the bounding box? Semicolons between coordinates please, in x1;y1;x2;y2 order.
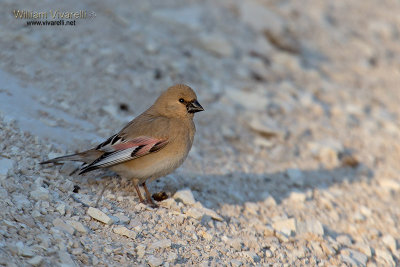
40;84;204;205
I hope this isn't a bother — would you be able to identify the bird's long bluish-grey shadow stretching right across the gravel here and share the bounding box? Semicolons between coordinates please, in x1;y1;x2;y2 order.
150;164;373;208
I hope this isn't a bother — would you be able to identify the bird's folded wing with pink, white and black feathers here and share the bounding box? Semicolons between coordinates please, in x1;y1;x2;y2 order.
79;135;168;174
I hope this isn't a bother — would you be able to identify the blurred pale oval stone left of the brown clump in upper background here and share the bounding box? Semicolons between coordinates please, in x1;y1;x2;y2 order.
198;34;233;57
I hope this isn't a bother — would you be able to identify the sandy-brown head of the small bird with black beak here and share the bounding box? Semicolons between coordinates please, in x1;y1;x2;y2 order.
152;84;204;118
